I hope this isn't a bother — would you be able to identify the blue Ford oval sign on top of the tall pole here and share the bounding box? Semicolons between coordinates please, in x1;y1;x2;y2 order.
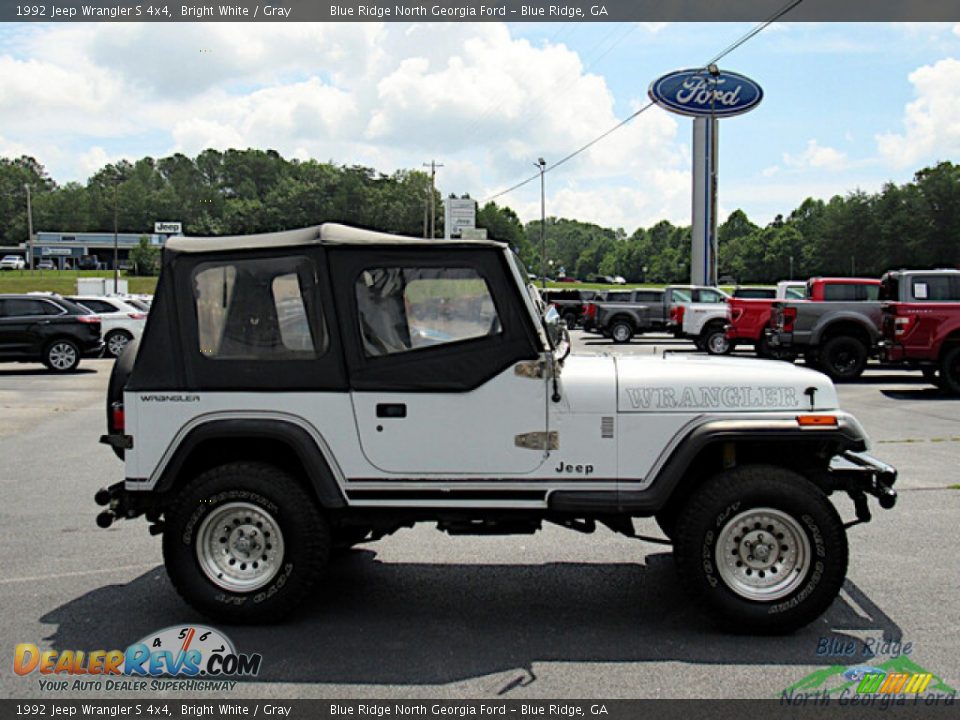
648;68;763;117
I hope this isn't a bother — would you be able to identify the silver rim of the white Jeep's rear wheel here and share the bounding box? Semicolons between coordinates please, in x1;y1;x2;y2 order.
196;502;283;592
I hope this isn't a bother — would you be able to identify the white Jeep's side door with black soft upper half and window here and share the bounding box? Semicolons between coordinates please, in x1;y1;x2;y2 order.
328;246;546;477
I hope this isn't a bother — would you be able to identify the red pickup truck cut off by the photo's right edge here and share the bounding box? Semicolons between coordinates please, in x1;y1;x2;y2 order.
880;270;960;395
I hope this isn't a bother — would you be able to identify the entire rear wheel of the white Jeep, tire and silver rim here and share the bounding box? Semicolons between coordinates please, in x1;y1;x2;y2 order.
163;462;331;623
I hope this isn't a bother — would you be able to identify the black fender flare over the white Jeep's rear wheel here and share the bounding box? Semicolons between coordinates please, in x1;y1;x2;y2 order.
154;418;346;509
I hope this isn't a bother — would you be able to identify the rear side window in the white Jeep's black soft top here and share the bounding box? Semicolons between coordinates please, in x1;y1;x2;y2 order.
193;258;328;360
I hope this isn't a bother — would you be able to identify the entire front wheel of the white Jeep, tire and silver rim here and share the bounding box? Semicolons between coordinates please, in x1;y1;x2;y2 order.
674;465;847;634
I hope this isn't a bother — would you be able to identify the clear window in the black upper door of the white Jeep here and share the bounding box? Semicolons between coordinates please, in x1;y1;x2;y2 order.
354;267;502;357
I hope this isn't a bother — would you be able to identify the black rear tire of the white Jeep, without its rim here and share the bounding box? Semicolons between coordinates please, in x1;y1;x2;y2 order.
163;462;332;624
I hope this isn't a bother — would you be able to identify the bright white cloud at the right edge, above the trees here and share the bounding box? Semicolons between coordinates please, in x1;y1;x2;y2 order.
876;58;960;168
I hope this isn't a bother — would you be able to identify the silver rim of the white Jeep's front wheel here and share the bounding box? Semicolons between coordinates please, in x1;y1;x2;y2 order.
716;508;811;602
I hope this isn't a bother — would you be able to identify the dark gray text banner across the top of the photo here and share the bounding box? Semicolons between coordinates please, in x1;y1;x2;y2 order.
0;0;960;22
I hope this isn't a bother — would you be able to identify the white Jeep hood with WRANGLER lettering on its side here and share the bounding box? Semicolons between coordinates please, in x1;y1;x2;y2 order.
615;354;838;412
